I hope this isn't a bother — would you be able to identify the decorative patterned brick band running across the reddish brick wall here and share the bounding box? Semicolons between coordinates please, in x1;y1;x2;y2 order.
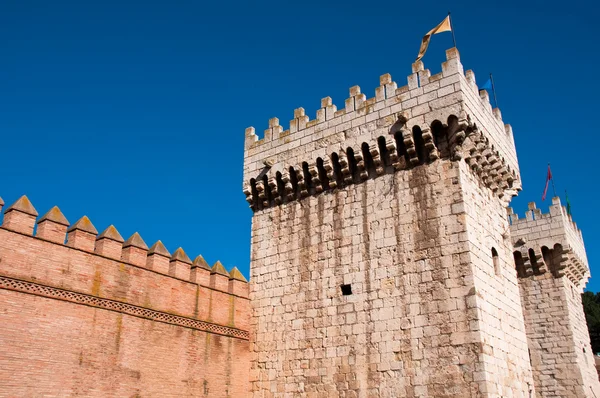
0;276;250;340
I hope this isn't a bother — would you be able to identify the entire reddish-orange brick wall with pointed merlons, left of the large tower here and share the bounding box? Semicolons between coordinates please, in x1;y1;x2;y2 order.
0;197;249;397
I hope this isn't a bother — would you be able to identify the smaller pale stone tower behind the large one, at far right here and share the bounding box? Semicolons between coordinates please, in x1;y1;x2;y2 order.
509;197;600;398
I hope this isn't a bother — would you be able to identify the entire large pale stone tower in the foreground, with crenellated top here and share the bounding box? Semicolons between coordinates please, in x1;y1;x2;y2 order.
244;49;533;397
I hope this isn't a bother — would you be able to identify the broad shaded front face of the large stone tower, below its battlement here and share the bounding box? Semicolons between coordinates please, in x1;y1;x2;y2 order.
251;163;466;397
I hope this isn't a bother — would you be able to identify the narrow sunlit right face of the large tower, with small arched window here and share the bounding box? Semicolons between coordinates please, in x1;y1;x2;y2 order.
461;165;534;397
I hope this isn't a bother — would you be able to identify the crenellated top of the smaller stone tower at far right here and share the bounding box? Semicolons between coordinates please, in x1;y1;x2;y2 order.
508;197;590;291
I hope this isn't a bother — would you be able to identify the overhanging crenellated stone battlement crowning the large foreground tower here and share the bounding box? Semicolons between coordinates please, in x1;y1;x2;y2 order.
243;48;521;210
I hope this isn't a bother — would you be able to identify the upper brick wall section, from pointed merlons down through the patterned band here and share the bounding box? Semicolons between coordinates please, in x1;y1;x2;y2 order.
0;196;249;339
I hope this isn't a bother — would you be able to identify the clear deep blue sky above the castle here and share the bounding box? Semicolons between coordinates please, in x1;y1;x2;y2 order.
0;0;600;291
